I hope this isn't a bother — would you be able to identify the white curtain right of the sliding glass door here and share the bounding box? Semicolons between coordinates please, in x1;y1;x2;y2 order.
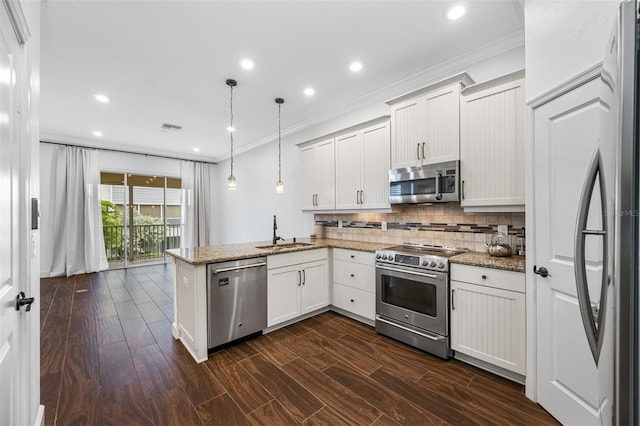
180;161;212;248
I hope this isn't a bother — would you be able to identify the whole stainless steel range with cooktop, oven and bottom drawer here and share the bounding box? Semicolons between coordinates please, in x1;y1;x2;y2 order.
376;243;466;359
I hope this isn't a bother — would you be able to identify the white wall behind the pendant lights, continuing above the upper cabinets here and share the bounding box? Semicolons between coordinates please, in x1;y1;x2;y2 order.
213;46;524;244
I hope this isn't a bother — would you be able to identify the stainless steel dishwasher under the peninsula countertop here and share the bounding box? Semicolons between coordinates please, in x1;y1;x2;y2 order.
207;257;267;349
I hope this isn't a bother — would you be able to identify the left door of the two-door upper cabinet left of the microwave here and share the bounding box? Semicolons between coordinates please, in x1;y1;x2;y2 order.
336;131;362;209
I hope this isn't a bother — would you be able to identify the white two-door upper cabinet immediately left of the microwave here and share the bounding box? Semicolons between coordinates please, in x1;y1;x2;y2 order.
335;121;391;209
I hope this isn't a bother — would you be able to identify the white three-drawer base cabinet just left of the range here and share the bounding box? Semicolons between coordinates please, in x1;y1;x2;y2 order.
333;248;376;321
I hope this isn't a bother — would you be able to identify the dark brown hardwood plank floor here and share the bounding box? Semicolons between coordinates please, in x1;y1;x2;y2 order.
41;265;557;426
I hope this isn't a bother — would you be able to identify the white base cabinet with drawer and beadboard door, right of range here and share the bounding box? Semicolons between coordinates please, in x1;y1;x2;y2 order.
451;264;526;375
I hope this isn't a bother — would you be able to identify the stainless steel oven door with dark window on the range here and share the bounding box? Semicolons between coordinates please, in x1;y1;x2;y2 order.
376;263;449;336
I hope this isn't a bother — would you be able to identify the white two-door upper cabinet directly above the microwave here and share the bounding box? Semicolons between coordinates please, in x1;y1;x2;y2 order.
387;73;473;169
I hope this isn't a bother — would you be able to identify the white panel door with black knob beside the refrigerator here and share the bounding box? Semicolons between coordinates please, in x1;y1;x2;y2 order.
532;79;611;425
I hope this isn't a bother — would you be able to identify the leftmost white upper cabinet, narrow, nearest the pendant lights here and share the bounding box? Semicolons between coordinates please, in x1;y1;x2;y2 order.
299;138;336;210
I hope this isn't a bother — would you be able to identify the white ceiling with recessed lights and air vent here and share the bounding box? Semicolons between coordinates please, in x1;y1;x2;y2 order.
40;0;523;161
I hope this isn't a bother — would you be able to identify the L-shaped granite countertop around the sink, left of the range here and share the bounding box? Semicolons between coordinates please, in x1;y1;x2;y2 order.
166;238;389;265
